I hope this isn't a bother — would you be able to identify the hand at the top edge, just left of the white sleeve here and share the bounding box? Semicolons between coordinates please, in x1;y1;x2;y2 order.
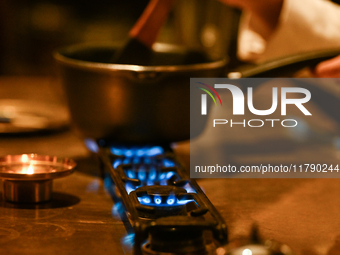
219;0;284;32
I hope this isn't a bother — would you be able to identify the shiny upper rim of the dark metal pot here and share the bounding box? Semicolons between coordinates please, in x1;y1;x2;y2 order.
53;43;228;72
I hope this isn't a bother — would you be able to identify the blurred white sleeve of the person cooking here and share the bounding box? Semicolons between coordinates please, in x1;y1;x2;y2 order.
238;0;340;62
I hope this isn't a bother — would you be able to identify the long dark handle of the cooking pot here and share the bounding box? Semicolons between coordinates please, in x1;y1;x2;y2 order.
226;48;340;78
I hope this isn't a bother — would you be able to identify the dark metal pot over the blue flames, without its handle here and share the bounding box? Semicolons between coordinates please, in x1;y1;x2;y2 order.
54;42;227;143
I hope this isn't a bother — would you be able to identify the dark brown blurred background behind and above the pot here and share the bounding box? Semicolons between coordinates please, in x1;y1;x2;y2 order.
0;0;239;75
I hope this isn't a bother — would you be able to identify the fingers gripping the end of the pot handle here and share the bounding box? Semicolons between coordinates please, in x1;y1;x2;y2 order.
314;55;340;78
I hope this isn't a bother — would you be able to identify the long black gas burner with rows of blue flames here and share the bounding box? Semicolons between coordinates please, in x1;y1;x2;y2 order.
95;146;228;255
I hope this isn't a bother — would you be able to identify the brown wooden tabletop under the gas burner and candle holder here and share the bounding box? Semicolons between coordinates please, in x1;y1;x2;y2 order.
0;77;340;255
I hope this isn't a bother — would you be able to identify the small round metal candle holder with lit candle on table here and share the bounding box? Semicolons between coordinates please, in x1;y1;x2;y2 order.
0;154;76;203
